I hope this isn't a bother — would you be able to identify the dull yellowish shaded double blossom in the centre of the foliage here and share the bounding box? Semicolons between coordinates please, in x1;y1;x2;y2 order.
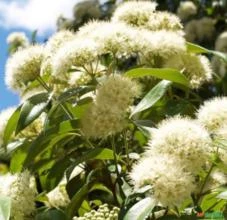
81;75;139;138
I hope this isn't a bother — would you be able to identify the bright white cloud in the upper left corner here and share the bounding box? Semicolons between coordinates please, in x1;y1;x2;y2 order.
0;0;79;34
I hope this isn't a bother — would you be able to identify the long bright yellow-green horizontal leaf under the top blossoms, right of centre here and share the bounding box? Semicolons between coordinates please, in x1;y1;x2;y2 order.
125;68;189;87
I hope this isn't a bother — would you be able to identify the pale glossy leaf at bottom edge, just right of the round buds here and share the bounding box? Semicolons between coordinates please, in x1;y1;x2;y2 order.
123;197;156;220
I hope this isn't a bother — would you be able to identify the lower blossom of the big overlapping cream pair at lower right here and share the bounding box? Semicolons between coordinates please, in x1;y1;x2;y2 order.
130;154;195;207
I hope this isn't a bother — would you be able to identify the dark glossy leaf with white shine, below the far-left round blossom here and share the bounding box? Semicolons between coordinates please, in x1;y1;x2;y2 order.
16;92;50;134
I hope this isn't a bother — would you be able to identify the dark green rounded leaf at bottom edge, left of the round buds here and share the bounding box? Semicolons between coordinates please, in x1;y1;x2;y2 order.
35;209;69;220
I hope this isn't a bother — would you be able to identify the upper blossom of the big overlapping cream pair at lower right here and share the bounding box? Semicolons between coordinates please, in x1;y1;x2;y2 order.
146;116;212;172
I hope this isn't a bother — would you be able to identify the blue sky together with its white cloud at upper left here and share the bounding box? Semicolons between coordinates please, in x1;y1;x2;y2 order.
0;0;82;111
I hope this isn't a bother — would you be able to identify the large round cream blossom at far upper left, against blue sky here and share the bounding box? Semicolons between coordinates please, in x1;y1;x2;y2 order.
5;45;44;91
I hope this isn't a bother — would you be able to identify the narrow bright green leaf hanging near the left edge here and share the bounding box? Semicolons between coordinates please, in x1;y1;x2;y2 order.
3;106;21;146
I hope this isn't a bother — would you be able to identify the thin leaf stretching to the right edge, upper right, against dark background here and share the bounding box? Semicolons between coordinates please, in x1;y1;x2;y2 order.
186;42;227;62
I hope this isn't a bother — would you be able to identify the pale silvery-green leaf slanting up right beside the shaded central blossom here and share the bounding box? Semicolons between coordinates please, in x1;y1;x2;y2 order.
130;80;171;117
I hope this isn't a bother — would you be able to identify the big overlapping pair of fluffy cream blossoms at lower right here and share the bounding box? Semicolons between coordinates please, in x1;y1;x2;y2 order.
130;117;212;207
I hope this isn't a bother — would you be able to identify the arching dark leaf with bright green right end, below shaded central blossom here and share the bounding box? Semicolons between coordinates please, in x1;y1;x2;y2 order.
66;148;114;179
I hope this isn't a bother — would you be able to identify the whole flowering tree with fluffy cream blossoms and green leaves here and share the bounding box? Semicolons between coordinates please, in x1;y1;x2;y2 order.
0;1;227;220
